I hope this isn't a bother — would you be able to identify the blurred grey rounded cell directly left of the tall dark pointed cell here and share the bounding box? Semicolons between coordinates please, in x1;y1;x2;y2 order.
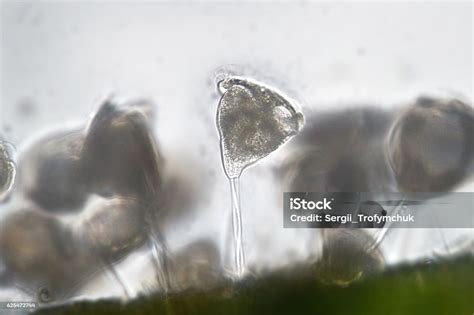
20;130;88;212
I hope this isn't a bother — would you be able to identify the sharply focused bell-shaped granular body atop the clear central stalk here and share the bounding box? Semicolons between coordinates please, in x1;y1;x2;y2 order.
217;77;304;178
